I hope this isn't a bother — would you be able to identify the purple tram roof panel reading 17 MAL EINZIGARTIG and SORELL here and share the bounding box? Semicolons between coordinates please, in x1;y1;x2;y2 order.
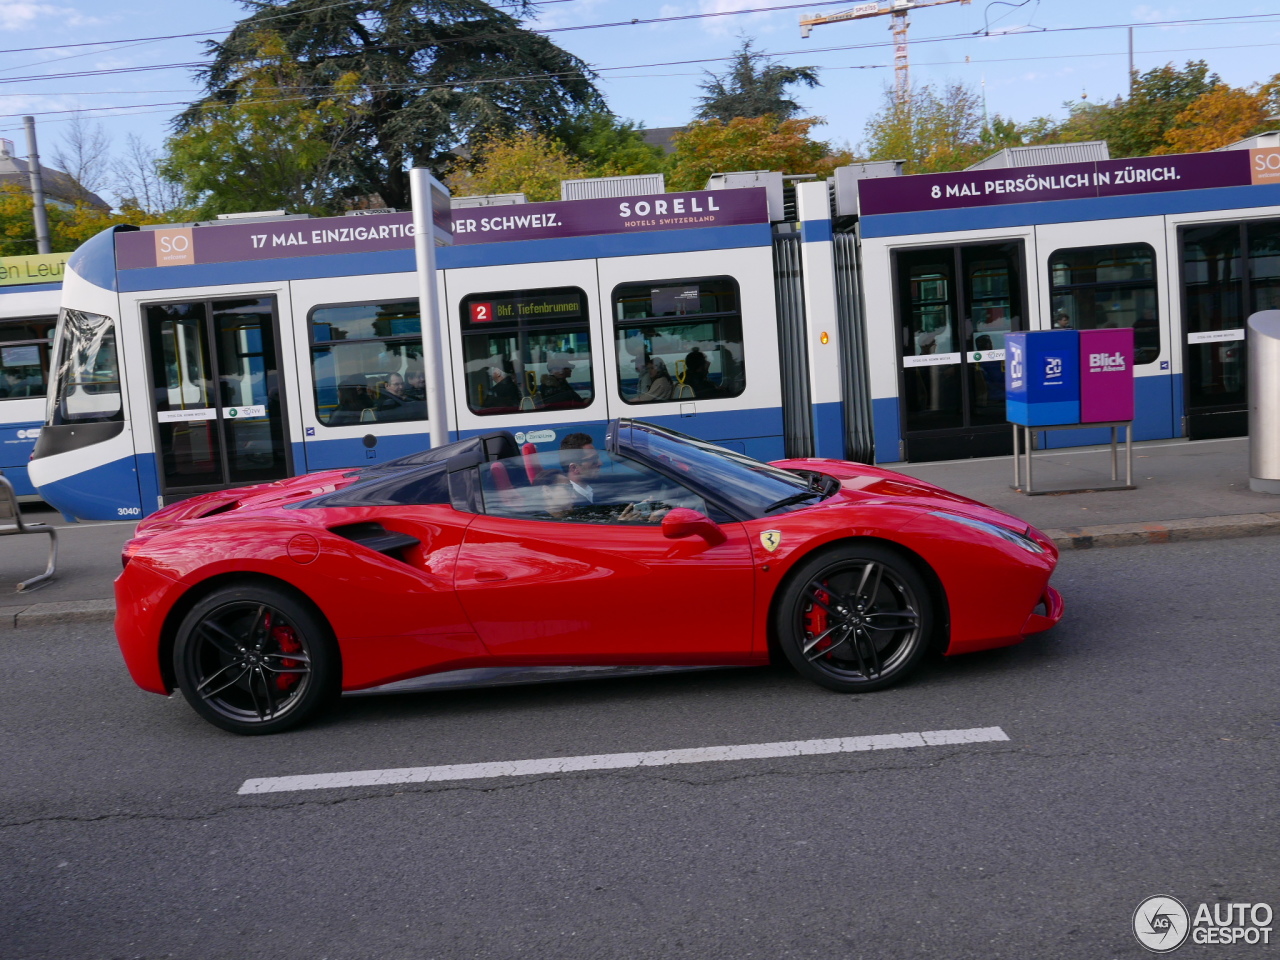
115;187;769;270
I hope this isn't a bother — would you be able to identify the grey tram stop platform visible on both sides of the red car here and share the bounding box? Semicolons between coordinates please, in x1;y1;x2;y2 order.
0;436;1280;630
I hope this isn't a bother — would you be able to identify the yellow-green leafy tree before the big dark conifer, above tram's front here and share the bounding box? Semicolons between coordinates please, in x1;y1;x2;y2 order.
162;31;365;216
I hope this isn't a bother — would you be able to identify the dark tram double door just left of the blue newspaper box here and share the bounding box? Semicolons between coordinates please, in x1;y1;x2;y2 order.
895;241;1027;461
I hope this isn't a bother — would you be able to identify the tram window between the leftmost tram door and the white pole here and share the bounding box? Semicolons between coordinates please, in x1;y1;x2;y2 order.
308;300;426;426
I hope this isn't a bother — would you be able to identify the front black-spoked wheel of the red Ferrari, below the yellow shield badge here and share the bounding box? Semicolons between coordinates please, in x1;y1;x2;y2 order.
774;544;933;692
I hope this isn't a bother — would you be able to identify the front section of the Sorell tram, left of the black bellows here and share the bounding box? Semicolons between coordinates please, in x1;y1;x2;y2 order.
32;184;836;520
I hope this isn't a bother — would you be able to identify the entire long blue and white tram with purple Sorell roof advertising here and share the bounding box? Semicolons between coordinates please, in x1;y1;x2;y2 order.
31;138;1280;520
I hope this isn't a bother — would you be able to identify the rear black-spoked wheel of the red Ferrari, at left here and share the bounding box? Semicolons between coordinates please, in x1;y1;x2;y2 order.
173;584;342;733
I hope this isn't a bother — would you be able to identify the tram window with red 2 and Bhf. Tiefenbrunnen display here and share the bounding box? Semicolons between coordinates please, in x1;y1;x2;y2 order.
460;287;595;416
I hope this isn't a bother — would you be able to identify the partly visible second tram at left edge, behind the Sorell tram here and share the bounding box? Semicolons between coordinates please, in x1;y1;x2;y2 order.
0;253;68;499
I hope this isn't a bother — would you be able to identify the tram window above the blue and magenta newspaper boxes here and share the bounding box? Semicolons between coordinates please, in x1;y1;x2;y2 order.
1048;243;1160;364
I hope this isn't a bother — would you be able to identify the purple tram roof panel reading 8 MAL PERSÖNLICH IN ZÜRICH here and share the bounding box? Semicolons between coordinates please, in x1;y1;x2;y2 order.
858;147;1280;216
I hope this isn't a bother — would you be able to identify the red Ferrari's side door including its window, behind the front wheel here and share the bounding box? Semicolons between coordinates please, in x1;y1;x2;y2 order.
456;451;755;664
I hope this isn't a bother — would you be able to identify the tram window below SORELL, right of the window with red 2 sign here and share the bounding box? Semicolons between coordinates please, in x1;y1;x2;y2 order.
613;276;746;403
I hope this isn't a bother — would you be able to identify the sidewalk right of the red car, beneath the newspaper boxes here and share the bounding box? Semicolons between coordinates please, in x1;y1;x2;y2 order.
884;436;1280;549
